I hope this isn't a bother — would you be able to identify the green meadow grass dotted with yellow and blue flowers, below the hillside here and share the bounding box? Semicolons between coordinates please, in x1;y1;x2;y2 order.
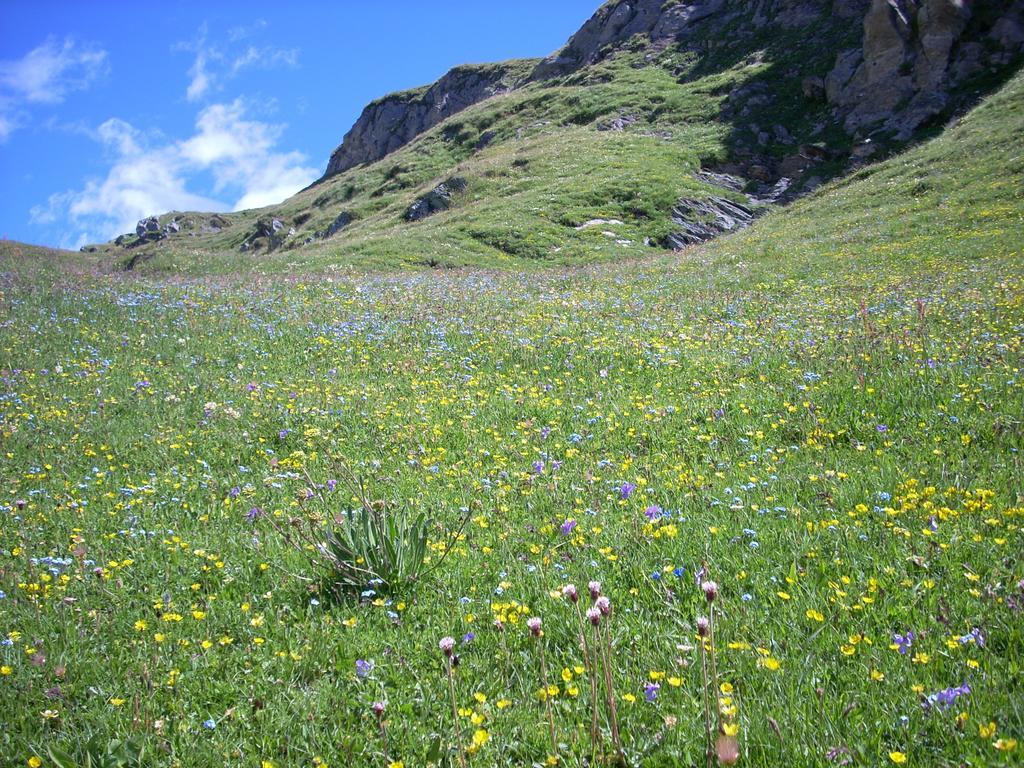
0;67;1024;768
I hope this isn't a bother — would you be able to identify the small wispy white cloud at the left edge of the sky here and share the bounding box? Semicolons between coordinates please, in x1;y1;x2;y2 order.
0;37;106;104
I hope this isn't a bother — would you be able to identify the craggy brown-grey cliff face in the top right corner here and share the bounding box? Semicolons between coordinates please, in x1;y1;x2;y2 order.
825;0;1024;141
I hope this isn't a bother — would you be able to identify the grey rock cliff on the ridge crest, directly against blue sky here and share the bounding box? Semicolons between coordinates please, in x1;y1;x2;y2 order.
324;61;529;178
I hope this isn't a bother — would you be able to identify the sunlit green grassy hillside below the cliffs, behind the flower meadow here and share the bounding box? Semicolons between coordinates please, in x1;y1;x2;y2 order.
77;7;872;273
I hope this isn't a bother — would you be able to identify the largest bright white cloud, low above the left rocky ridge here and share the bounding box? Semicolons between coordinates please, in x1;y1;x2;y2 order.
32;99;319;246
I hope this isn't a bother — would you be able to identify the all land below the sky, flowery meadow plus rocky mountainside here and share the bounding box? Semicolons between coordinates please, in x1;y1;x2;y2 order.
0;0;1024;768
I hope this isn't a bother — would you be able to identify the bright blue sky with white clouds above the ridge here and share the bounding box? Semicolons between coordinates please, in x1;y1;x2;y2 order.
0;0;600;248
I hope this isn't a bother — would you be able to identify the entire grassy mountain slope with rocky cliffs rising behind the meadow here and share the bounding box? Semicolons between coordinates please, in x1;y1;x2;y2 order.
83;0;1024;271
